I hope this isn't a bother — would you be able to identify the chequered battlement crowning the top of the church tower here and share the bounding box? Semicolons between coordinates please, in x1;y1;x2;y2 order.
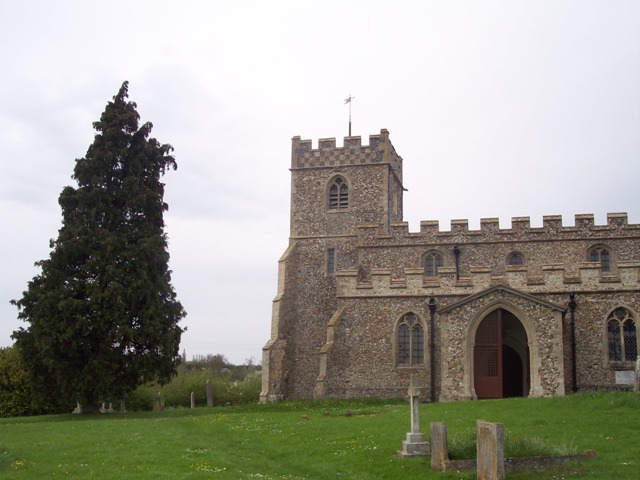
291;128;402;178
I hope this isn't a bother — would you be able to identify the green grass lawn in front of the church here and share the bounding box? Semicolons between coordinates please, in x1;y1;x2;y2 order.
0;392;640;480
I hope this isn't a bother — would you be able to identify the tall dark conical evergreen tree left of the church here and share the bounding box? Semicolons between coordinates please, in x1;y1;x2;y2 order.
13;82;185;411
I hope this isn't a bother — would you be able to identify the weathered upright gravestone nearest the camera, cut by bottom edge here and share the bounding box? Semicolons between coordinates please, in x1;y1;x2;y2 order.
476;420;504;480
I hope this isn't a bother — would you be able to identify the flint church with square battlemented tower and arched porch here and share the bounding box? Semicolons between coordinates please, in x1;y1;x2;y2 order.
260;129;640;402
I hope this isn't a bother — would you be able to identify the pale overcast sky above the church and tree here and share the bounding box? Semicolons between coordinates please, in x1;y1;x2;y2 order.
0;0;640;363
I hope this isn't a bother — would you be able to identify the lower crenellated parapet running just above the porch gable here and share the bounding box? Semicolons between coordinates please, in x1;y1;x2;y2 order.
336;262;640;298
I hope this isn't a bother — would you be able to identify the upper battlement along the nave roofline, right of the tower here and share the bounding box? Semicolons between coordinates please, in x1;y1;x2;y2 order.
359;213;640;241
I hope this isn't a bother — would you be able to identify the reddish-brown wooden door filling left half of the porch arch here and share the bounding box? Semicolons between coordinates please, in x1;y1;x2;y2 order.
473;310;502;398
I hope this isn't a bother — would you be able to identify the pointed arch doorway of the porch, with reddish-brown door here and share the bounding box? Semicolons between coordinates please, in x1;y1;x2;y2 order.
473;308;530;399
